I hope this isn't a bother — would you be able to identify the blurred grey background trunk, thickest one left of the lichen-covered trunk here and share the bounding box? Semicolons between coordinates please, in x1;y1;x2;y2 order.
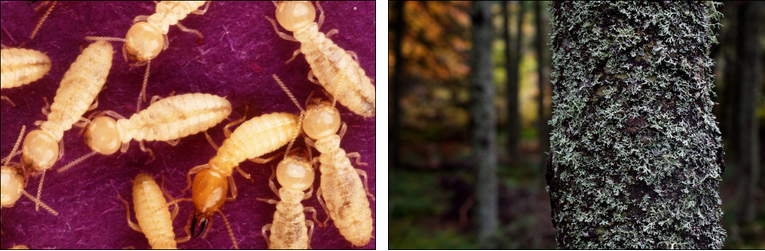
470;2;499;242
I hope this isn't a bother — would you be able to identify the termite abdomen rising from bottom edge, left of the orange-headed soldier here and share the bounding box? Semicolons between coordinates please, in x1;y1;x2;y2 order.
117;173;191;249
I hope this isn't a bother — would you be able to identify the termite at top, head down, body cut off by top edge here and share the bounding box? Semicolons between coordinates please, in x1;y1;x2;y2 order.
85;1;210;111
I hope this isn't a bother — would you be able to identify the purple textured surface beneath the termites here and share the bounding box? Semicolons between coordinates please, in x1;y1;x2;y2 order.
0;2;377;249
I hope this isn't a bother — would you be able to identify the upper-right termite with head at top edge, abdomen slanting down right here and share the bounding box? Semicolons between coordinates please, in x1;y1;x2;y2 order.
266;1;375;118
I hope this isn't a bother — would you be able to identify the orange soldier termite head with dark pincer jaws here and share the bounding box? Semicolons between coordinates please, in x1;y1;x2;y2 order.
191;168;228;238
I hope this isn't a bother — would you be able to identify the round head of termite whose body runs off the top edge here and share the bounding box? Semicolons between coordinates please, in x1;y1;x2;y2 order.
124;22;165;62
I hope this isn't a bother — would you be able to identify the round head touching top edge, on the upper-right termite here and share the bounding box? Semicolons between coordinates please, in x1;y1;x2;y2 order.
276;1;316;31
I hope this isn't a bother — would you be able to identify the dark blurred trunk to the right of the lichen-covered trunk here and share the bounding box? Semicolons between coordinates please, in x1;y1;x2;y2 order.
734;2;765;224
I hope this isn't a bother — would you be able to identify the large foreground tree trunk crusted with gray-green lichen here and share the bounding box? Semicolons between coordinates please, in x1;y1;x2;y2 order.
546;1;726;249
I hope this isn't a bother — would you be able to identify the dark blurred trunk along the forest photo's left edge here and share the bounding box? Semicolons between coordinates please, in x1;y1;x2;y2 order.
389;1;406;168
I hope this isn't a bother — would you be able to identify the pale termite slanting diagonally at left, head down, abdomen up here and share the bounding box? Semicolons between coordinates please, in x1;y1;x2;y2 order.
22;41;114;210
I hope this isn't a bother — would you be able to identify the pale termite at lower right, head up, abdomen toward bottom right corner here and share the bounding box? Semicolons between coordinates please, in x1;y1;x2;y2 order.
275;77;375;246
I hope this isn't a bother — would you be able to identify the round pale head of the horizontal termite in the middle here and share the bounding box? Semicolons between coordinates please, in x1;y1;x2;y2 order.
84;116;121;155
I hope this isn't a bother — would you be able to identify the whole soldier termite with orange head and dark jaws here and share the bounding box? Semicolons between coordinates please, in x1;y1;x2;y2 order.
186;109;299;242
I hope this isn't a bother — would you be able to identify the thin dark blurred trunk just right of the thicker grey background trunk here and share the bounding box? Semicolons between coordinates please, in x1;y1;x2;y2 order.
503;1;523;164
